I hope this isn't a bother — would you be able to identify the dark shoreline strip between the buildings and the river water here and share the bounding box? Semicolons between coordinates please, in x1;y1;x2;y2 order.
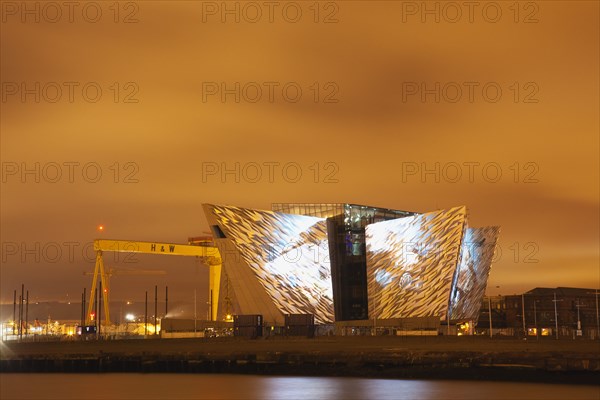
0;337;600;385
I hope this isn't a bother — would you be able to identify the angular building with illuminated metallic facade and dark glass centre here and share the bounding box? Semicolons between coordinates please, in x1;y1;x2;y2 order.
203;203;499;325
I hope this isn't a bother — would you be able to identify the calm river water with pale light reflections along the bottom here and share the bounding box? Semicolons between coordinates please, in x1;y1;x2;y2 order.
0;374;600;400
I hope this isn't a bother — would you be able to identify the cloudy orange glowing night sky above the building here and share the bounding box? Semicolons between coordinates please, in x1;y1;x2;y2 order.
0;1;600;302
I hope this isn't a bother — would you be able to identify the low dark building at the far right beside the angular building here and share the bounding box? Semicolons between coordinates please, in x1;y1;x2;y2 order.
477;287;600;339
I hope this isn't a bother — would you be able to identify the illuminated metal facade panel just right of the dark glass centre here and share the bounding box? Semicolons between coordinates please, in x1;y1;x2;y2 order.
366;207;466;318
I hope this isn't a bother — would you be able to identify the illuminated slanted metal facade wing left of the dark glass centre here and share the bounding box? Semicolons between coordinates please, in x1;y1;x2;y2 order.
205;205;333;323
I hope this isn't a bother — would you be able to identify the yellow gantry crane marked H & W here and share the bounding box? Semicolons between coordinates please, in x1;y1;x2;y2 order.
86;238;222;325
